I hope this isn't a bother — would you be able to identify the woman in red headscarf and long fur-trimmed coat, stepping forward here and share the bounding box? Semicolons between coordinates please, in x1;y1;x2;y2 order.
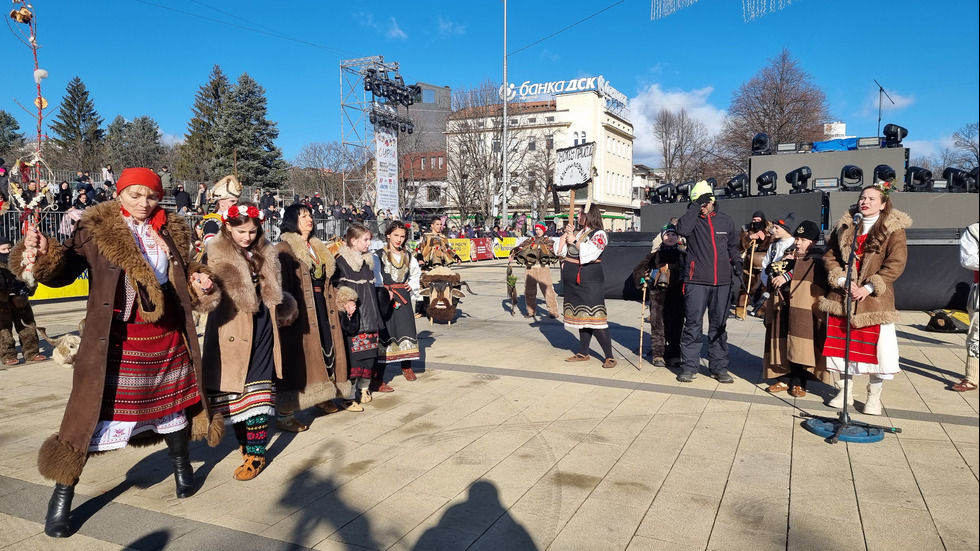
11;168;224;538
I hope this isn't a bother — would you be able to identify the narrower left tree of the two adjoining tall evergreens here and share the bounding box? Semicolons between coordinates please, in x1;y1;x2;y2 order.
176;65;229;183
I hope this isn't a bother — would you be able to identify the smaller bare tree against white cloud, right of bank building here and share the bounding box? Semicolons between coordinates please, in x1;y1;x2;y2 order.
653;107;711;183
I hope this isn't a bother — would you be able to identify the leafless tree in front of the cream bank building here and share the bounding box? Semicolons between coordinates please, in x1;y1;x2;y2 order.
446;80;530;225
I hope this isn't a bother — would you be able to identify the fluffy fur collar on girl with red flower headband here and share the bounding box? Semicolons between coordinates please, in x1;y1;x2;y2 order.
207;234;283;314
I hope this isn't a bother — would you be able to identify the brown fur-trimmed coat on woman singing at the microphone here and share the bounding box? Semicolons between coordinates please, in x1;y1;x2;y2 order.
820;209;912;328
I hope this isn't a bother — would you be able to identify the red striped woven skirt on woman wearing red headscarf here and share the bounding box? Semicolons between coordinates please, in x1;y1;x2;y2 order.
99;311;201;421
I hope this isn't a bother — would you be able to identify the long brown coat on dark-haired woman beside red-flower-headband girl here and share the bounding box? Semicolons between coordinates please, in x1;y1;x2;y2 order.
276;233;357;411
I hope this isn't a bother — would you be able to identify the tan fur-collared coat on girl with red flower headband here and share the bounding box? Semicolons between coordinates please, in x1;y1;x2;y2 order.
204;233;296;393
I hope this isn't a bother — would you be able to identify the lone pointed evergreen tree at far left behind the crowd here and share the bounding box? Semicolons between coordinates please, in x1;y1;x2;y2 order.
51;76;104;170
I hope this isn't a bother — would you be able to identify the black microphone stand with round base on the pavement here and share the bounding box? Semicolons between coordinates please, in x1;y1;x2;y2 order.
802;216;902;444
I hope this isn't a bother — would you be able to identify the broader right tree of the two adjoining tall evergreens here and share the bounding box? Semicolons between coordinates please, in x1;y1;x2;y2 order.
211;73;286;188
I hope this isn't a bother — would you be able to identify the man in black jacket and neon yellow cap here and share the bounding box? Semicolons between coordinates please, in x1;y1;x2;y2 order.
677;180;742;383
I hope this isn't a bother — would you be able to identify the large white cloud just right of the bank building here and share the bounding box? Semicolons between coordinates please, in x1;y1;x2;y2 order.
630;83;726;167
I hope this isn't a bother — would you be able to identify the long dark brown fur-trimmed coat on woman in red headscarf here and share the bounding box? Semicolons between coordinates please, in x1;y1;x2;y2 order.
10;201;224;484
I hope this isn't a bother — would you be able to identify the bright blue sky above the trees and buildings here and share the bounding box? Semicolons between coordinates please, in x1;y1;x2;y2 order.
0;0;980;165
